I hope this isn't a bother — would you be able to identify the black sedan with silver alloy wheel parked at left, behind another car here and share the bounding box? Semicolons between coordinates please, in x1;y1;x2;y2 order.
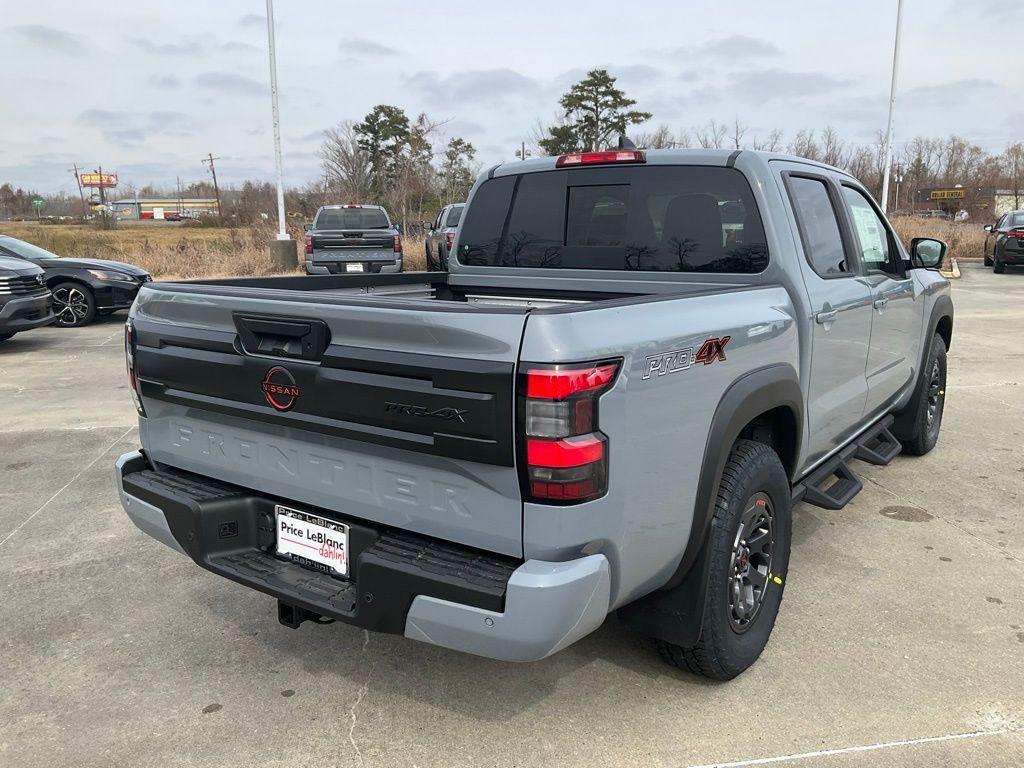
0;236;153;328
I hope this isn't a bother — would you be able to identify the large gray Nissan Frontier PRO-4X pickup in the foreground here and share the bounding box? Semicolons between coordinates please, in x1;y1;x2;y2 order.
117;150;953;679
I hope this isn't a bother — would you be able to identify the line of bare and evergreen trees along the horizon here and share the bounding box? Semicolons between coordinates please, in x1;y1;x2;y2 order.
0;69;1024;224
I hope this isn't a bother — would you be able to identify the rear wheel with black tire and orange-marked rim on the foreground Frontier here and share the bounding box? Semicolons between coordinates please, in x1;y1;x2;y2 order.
654;439;793;680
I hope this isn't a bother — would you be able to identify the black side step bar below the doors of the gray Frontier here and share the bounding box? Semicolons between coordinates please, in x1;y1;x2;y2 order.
793;416;902;509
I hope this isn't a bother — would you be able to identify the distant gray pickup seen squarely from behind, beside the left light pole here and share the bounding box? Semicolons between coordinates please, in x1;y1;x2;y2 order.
306;204;401;274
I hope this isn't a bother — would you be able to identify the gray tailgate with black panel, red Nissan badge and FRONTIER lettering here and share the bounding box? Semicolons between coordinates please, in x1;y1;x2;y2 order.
132;285;526;556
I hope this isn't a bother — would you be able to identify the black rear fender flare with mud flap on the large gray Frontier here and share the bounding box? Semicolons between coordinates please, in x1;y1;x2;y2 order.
618;364;804;646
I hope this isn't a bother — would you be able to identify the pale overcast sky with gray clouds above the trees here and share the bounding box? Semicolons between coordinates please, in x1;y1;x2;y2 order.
0;0;1024;193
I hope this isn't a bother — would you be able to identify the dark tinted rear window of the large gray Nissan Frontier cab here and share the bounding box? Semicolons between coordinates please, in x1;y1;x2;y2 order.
459;166;768;273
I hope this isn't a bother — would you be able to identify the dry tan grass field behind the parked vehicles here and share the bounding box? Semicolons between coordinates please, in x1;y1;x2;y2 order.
0;216;985;280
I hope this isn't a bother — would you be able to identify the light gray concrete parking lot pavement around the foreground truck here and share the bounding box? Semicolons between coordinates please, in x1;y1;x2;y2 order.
0;266;1024;768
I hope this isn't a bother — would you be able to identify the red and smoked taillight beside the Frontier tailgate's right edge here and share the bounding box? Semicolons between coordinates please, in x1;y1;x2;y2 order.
519;361;618;504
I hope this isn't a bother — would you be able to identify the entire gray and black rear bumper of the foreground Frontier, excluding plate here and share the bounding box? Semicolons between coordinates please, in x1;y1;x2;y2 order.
116;452;610;662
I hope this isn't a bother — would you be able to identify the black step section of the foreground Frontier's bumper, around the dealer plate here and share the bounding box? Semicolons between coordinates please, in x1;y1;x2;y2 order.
122;461;521;634
